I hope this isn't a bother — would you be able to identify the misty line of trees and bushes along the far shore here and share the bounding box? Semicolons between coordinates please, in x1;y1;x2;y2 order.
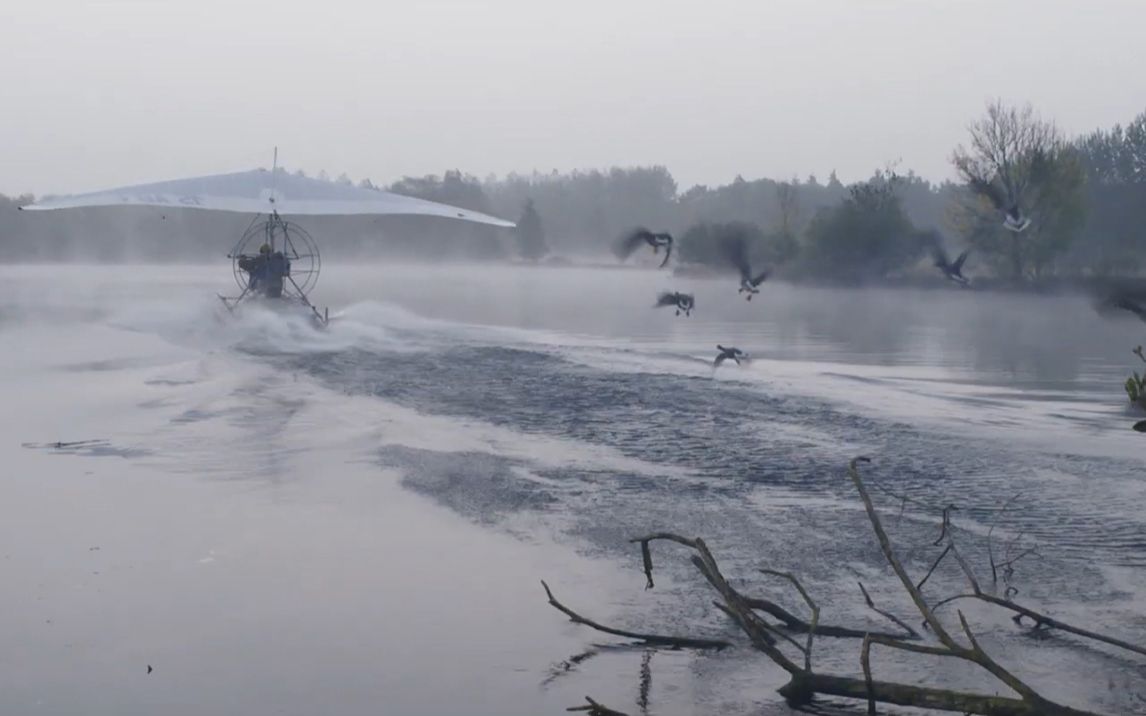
0;102;1146;282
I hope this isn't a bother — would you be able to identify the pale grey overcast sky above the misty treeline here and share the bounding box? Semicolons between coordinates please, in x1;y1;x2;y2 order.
0;0;1146;194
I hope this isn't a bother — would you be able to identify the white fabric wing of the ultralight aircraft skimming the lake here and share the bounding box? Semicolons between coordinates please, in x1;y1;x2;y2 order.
23;170;515;227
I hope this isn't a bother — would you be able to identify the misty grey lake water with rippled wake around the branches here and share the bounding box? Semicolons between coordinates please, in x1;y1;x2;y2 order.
0;265;1146;715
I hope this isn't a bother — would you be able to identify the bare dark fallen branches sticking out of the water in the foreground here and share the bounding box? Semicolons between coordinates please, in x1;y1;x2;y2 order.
545;458;1146;716
